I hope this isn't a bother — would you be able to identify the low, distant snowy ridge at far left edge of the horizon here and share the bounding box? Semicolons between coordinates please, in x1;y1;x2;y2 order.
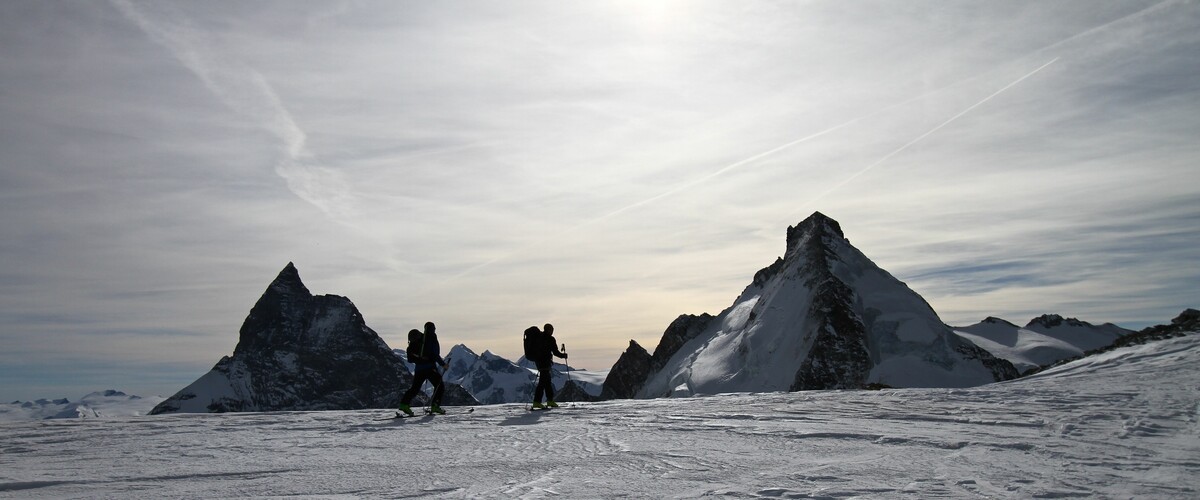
0;390;166;421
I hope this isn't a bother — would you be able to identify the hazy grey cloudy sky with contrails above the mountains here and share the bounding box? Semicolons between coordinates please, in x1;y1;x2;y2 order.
0;0;1200;402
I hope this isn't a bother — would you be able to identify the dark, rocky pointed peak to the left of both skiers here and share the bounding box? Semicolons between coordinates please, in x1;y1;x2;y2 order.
152;263;413;414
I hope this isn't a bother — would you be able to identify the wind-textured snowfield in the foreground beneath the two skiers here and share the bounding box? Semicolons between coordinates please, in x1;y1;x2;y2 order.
0;335;1200;499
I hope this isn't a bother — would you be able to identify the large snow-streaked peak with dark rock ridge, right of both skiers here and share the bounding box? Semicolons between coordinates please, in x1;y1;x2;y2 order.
604;212;1018;398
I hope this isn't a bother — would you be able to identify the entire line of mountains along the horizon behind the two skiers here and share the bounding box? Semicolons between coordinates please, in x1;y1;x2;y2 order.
25;212;1180;417
